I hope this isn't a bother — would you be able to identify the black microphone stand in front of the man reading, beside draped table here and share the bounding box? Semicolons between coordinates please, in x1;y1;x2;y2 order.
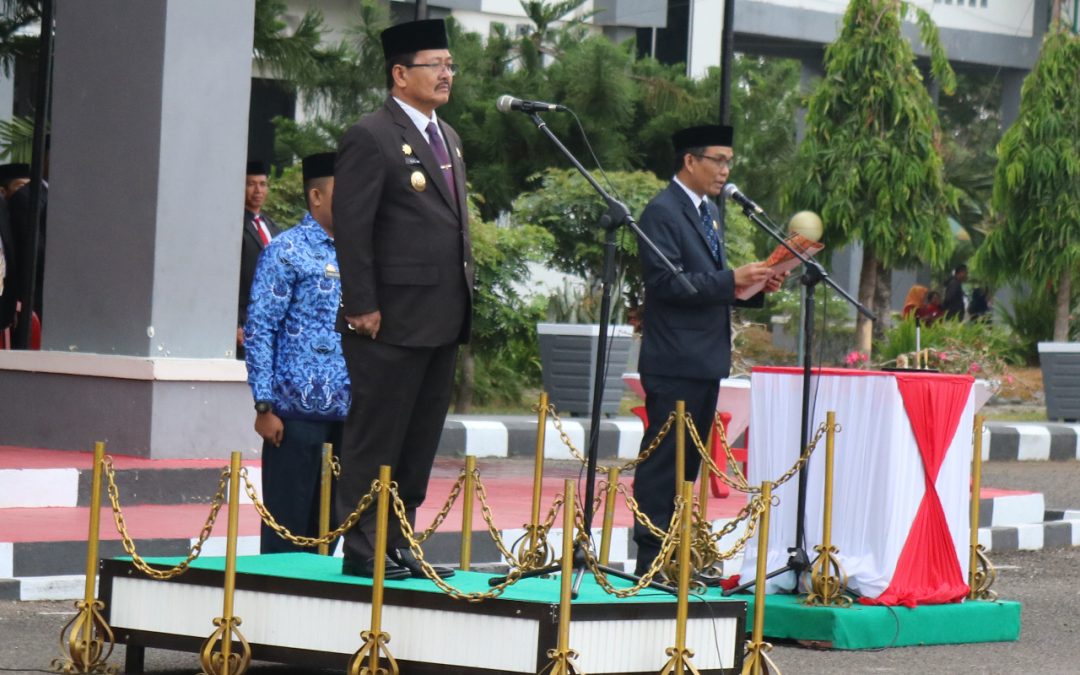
724;202;877;595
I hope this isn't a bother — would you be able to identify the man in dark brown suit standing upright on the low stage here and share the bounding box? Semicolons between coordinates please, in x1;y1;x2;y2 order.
334;21;473;578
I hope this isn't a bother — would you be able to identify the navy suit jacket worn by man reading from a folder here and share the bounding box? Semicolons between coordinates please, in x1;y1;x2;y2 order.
638;181;762;380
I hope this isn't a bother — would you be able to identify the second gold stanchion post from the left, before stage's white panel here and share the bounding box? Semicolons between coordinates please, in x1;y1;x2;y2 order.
199;453;252;675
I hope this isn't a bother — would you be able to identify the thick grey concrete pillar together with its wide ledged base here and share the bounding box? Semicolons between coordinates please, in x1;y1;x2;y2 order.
0;0;258;457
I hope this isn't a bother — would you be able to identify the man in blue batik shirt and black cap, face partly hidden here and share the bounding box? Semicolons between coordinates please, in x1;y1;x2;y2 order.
244;152;350;553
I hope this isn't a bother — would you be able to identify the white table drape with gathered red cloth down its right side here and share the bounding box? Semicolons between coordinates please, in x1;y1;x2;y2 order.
742;367;975;606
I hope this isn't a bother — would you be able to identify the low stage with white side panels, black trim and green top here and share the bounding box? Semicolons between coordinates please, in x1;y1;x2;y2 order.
99;553;747;675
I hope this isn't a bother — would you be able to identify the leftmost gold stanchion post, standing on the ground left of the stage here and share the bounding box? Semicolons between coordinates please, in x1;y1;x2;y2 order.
52;441;116;673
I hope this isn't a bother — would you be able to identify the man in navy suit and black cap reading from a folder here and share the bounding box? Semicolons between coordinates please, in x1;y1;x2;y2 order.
634;125;783;575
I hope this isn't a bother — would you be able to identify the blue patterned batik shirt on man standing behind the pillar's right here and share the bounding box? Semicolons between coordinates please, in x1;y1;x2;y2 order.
244;214;349;420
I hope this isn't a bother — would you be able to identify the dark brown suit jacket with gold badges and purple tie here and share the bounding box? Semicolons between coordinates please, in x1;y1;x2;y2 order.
334;98;473;347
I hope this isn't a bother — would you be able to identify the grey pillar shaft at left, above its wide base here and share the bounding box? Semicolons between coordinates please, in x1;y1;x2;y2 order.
42;0;254;357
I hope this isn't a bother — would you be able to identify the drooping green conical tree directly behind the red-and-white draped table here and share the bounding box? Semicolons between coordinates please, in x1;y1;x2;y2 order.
784;0;957;352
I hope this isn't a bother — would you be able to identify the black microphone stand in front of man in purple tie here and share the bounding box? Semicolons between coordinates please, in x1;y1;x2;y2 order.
489;110;698;597
